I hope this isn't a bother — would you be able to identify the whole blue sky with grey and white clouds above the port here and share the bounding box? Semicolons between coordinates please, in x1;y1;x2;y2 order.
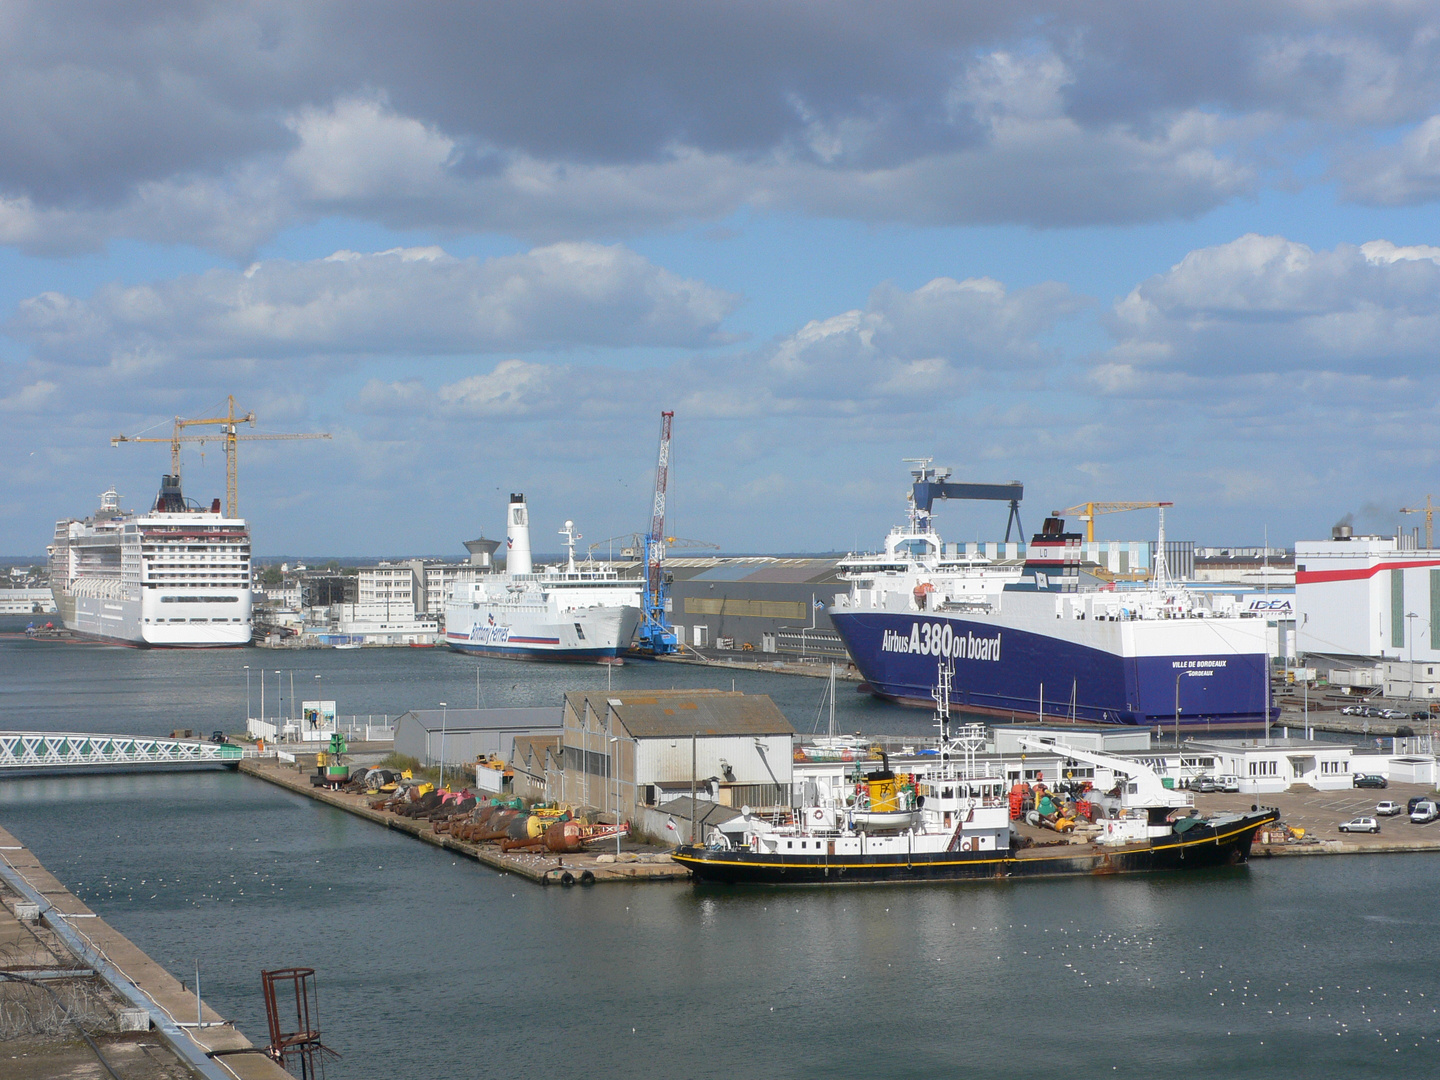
0;0;1440;557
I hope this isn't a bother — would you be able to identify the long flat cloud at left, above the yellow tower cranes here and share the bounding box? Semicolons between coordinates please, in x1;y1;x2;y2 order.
6;243;736;363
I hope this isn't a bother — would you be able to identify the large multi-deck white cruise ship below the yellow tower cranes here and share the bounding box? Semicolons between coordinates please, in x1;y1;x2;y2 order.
49;475;251;648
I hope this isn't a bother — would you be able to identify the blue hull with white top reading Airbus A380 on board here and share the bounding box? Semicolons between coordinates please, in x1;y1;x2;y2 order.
831;606;1274;732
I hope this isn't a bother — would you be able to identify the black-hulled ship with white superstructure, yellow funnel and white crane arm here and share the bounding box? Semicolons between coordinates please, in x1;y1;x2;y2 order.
671;662;1280;884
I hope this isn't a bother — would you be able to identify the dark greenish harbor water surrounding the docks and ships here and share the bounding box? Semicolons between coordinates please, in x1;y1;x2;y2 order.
0;630;1440;1080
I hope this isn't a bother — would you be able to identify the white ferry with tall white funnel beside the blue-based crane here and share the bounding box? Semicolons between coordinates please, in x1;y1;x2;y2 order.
445;495;644;664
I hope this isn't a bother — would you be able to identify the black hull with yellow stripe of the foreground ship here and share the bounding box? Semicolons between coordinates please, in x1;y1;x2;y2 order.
671;809;1279;886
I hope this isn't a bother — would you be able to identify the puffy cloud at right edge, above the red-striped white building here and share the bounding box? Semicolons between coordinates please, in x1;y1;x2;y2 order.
1097;233;1440;377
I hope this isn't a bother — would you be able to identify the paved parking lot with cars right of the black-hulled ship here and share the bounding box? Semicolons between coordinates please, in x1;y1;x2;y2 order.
1195;783;1440;854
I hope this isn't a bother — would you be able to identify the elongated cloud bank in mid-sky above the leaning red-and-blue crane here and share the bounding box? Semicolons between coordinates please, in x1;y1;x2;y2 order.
342;270;1087;425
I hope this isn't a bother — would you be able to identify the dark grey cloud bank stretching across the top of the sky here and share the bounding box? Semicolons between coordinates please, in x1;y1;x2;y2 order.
8;3;1440;249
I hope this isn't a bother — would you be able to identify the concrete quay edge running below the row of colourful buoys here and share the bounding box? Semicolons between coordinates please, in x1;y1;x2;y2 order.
239;759;690;886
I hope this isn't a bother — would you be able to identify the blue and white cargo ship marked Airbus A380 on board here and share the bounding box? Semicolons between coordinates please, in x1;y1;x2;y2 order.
829;466;1276;732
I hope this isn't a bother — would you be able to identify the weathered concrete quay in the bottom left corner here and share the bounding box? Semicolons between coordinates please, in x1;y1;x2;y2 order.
0;828;289;1080
